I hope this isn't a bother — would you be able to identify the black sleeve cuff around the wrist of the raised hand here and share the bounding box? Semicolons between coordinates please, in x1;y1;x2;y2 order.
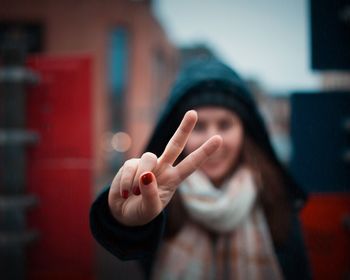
90;187;165;260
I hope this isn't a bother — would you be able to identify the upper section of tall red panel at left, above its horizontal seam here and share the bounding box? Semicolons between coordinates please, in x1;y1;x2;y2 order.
28;57;92;159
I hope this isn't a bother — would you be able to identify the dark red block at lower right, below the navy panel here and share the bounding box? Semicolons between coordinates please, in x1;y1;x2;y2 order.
302;193;350;280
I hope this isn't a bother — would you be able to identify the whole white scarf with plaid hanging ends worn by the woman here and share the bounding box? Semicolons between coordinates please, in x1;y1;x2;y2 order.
152;168;283;280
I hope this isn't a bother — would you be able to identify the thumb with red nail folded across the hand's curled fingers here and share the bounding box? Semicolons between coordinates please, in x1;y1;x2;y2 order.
139;172;162;219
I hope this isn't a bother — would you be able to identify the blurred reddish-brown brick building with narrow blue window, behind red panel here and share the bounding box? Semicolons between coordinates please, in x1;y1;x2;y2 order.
0;0;178;179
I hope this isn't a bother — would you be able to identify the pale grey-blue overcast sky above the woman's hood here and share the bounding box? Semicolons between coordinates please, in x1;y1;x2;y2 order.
153;0;320;94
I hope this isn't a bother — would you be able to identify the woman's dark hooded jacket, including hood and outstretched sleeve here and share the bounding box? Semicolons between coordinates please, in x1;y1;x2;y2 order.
90;60;310;279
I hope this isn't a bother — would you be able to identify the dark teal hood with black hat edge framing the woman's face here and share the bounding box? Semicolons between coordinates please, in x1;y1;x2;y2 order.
145;59;306;208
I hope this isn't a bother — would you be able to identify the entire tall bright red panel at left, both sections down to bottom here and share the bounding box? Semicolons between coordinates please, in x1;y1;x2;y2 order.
27;56;94;279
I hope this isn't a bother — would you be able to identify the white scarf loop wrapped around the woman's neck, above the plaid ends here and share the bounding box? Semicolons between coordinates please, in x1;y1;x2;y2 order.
179;169;257;233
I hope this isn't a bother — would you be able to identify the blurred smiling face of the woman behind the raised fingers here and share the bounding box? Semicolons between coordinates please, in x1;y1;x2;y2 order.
185;106;244;186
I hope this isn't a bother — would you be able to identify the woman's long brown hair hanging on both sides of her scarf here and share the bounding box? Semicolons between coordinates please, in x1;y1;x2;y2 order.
165;133;292;245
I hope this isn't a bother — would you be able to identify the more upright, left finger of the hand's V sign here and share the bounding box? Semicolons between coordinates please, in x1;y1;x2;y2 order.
159;110;198;165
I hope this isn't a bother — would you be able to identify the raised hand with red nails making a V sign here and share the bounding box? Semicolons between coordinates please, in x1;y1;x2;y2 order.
108;110;222;226
